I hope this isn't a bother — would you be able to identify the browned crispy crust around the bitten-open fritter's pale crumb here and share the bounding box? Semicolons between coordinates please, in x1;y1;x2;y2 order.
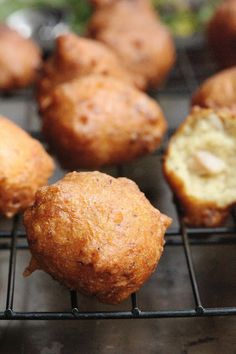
163;107;236;227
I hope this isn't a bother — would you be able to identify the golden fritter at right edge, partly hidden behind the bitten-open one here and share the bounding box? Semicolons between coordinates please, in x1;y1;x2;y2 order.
192;68;236;111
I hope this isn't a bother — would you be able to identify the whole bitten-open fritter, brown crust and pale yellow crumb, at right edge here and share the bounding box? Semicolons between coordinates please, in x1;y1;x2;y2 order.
164;108;236;227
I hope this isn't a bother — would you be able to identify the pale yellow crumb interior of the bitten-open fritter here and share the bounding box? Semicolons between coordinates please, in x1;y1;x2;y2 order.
166;113;236;207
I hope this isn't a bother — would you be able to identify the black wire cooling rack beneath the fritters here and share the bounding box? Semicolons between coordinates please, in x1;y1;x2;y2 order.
0;37;236;320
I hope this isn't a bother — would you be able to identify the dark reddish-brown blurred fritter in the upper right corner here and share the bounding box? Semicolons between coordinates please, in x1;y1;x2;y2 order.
208;0;236;67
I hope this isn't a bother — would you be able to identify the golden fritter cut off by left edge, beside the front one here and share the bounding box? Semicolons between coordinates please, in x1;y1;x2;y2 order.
0;116;54;217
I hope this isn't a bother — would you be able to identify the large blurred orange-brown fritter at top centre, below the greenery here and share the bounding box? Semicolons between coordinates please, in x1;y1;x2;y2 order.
89;0;175;89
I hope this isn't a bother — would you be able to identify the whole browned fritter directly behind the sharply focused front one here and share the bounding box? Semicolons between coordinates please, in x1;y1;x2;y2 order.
43;75;167;170
